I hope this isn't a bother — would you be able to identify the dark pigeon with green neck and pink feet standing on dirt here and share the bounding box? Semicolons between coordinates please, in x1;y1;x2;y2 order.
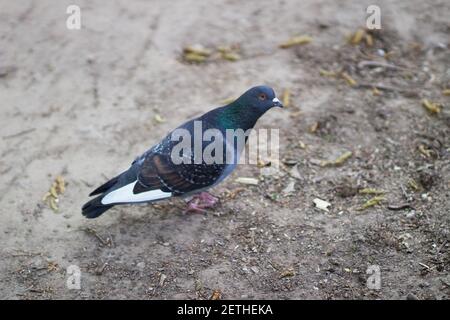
82;85;283;219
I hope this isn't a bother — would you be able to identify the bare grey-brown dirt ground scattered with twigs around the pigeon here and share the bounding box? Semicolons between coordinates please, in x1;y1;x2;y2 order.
0;0;450;299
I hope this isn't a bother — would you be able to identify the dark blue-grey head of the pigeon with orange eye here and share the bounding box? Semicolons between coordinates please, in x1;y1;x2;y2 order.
237;86;283;113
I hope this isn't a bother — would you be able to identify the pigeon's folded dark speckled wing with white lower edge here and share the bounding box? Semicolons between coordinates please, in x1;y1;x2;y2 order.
102;115;230;205
